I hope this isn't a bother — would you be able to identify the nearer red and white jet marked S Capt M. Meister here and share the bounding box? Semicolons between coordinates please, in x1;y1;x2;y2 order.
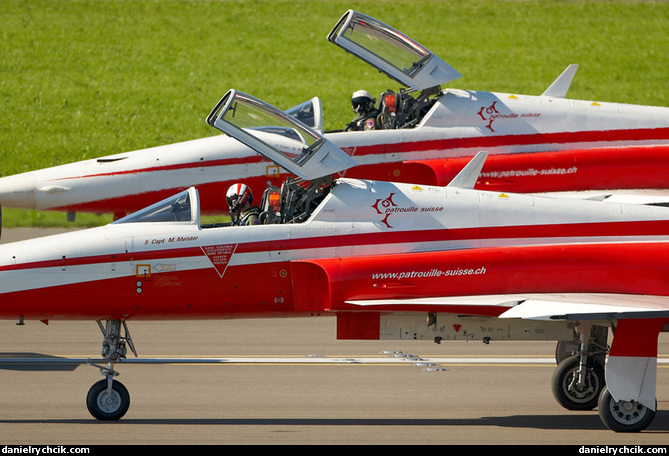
0;90;669;432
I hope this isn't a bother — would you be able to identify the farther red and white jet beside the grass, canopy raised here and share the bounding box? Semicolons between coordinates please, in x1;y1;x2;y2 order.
0;11;669;218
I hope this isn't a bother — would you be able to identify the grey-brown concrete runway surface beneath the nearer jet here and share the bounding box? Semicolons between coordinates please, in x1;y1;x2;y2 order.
0;230;669;446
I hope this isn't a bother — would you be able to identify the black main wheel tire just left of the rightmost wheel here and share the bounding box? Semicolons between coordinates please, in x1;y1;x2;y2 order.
551;356;606;410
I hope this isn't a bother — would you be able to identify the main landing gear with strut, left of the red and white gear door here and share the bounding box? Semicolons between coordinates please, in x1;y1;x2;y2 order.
551;324;607;410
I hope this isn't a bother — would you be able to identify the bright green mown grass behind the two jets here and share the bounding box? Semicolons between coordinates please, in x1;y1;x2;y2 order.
0;0;669;226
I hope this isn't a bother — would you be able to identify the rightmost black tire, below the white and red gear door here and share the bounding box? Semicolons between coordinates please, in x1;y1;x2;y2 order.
598;388;655;432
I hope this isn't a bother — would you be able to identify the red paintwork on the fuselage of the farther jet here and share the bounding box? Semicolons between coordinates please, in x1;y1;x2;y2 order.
49;128;669;216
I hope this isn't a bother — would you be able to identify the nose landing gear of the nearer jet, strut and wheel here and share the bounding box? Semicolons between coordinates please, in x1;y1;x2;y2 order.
86;320;137;421
